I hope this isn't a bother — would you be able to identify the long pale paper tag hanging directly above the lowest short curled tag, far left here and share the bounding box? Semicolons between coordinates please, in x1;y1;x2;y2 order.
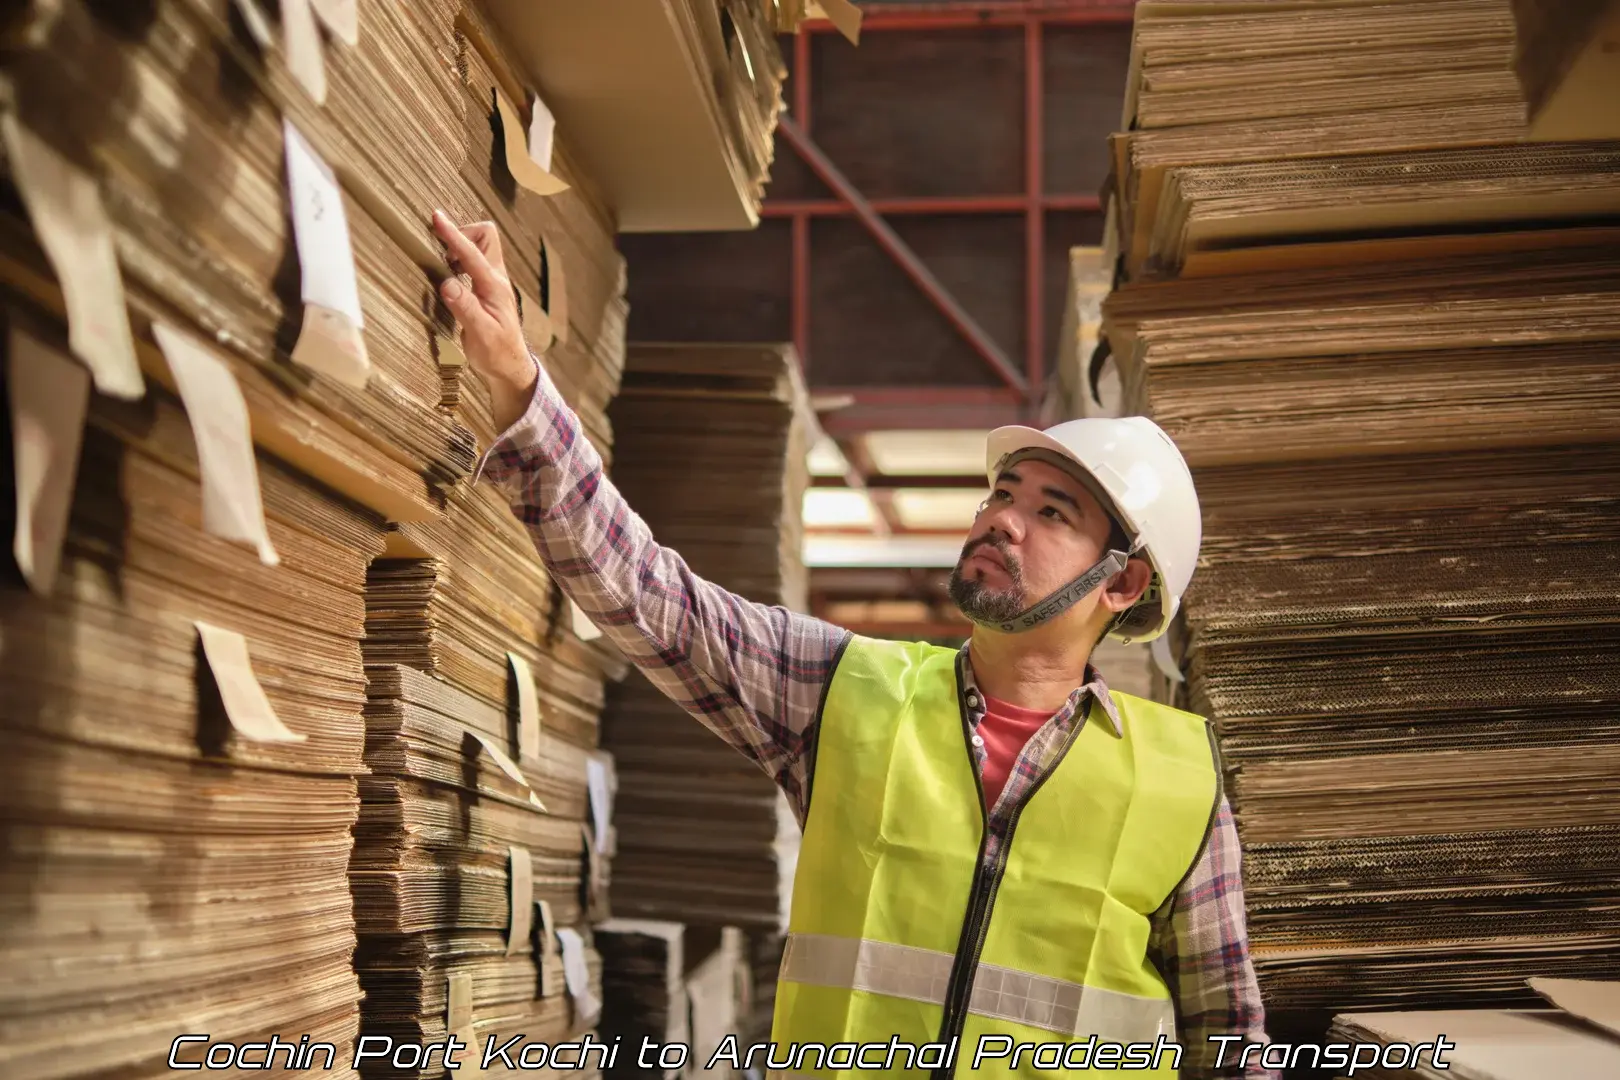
152;322;280;567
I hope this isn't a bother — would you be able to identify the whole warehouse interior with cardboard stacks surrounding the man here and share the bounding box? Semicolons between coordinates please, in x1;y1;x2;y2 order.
0;0;1620;1080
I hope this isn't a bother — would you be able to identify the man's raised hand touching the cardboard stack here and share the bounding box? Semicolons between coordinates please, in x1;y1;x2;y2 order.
433;210;538;431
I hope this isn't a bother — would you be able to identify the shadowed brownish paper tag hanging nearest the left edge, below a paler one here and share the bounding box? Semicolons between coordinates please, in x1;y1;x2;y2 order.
6;330;91;596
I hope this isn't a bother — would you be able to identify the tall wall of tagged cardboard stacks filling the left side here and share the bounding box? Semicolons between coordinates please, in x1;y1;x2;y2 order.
0;0;625;1077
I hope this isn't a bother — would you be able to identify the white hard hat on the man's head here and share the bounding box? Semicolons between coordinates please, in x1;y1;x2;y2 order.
985;416;1204;641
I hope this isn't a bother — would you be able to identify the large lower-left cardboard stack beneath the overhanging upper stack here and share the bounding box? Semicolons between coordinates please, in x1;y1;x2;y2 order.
0;318;384;1077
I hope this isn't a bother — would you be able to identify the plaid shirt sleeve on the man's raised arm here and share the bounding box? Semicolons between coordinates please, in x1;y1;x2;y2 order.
475;364;847;813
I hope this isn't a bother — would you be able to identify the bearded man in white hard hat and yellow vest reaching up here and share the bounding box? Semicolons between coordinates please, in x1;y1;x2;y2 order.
434;214;1272;1078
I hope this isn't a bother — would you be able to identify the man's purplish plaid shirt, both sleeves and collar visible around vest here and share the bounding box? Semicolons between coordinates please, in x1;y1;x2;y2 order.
480;366;1277;1080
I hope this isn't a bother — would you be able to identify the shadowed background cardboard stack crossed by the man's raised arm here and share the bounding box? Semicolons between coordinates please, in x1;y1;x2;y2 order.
603;345;812;929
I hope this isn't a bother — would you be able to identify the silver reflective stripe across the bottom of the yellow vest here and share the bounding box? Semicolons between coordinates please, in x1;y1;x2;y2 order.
779;934;1176;1043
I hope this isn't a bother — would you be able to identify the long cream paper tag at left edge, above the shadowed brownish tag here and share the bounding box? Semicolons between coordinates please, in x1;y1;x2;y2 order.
0;112;146;402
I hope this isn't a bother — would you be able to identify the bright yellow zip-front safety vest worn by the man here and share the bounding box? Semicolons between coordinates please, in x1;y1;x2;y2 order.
757;636;1220;1078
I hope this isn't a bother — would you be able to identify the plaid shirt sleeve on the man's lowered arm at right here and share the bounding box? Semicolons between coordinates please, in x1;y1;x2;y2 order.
1149;797;1281;1080
